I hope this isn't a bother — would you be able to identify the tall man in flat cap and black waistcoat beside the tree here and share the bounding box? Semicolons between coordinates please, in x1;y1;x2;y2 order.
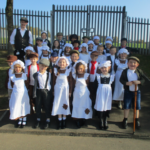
10;17;32;60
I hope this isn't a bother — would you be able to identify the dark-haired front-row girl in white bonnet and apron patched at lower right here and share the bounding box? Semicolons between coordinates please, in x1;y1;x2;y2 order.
72;60;92;128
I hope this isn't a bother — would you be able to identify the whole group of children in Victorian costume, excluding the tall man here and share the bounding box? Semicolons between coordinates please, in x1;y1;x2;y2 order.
6;31;144;130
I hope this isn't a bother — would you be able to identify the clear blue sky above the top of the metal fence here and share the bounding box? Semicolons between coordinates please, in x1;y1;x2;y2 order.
0;0;150;18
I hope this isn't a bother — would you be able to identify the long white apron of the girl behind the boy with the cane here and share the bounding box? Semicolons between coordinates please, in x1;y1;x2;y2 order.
113;59;128;101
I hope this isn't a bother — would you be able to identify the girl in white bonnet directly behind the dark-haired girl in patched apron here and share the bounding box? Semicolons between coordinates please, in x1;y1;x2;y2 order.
79;43;90;64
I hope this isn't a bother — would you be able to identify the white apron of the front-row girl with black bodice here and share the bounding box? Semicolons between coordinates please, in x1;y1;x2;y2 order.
94;74;115;111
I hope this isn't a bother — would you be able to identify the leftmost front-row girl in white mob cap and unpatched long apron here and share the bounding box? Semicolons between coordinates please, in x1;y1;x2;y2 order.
9;60;30;127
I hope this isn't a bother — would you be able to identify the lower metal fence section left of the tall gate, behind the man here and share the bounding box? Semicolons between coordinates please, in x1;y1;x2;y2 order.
0;9;51;49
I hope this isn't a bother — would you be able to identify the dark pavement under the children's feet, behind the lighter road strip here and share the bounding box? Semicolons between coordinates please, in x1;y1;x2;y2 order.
0;77;150;140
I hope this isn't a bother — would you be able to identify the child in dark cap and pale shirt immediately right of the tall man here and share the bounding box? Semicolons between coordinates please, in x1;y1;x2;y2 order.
34;37;43;62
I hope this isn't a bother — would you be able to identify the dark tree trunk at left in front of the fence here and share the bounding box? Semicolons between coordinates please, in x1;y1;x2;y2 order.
5;0;13;54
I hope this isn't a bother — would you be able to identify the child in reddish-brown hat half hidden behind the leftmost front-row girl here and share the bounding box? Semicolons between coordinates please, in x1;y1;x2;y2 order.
5;55;17;100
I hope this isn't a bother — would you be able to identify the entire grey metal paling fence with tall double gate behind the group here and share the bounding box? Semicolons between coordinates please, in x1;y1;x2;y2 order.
0;5;150;54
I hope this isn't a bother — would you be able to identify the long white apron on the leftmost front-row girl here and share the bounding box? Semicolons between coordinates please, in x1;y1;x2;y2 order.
9;73;30;120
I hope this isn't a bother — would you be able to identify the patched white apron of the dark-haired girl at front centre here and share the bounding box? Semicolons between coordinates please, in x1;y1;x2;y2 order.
72;73;92;119
